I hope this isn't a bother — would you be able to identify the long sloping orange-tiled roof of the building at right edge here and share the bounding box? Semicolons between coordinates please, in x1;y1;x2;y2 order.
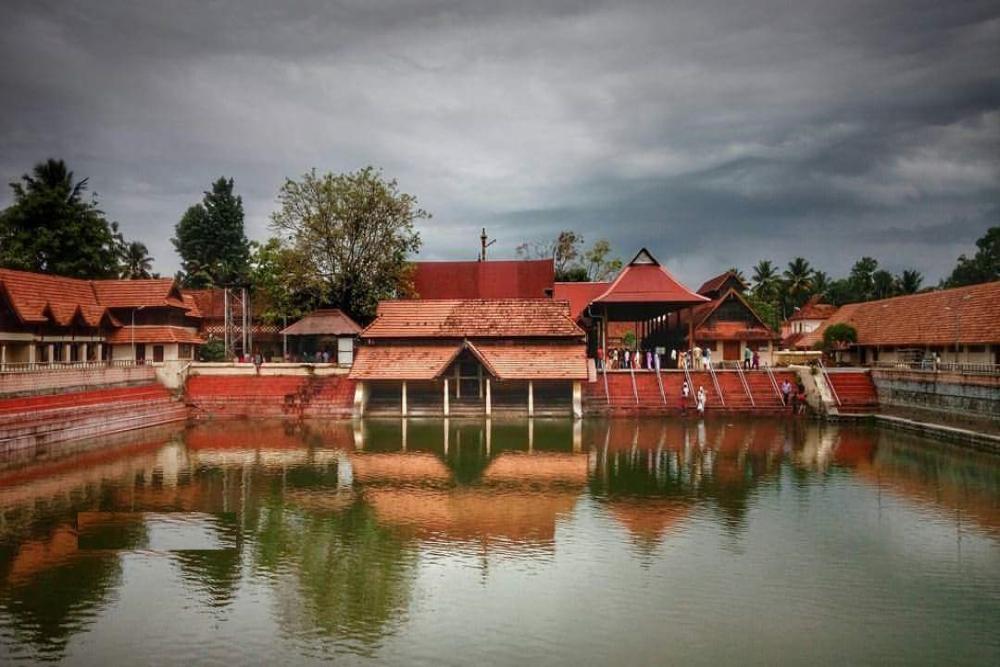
797;281;1000;349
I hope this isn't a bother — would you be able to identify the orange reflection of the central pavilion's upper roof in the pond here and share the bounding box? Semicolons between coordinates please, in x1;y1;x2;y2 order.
364;487;579;544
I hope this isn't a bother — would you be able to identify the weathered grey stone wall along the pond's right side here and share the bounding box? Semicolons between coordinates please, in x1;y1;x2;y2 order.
872;369;1000;419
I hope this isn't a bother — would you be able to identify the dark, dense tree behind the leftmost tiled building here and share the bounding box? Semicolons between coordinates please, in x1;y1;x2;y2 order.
0;159;120;278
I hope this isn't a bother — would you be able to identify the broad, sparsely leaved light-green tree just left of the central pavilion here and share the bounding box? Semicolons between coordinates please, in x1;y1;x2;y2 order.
271;167;430;320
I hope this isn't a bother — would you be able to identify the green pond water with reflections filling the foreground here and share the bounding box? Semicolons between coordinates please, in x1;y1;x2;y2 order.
0;419;1000;665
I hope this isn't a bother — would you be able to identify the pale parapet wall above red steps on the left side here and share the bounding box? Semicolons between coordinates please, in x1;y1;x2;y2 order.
0;366;156;398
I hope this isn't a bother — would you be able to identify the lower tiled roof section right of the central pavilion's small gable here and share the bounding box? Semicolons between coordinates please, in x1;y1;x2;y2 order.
469;343;587;380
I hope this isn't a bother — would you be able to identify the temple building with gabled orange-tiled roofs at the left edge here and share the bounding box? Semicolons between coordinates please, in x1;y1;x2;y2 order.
0;269;204;368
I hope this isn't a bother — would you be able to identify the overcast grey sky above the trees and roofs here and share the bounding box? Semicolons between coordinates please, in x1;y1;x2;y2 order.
0;0;1000;283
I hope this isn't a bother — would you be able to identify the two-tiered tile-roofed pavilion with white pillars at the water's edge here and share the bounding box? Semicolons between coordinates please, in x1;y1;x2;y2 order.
350;298;588;416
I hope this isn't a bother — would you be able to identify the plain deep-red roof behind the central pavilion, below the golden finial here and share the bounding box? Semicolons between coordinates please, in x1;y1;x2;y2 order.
413;259;555;299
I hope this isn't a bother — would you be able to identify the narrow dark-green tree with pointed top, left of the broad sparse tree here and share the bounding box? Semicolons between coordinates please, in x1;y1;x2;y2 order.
171;178;250;287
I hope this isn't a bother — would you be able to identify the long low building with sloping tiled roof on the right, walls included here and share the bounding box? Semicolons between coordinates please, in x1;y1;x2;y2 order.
796;282;1000;364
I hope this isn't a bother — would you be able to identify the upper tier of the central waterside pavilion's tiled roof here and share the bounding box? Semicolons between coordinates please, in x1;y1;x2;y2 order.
361;299;584;338
